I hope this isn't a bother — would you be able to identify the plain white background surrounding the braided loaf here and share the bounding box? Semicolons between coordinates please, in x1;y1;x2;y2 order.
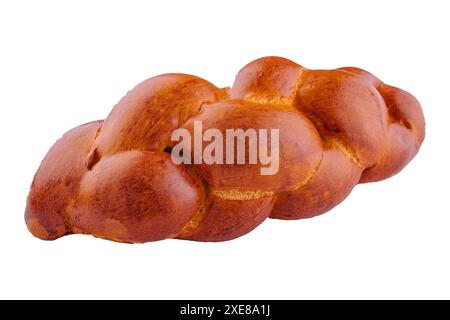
0;0;450;299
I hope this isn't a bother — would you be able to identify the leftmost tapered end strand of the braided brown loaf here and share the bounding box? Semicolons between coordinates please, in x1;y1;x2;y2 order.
25;121;103;240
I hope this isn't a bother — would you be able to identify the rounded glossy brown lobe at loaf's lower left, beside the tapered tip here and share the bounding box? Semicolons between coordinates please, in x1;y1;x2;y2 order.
71;151;204;242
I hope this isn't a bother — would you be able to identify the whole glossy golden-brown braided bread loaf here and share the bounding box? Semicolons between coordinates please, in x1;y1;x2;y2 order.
25;57;425;243
